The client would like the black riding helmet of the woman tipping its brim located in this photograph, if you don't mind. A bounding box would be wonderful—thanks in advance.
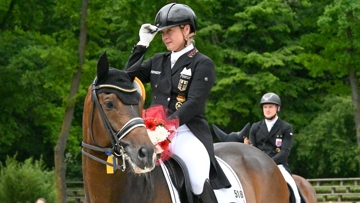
[155,3,197,32]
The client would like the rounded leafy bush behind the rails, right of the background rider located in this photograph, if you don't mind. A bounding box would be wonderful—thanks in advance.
[294,96,359,178]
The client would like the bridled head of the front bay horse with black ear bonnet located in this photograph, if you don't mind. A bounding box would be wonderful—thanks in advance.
[83,53,156,173]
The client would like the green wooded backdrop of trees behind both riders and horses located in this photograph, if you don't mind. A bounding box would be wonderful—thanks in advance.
[0,0,360,201]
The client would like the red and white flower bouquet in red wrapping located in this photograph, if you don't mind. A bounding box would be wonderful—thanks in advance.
[142,105,179,164]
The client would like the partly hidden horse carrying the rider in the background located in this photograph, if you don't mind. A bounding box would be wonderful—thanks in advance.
[213,123,318,203]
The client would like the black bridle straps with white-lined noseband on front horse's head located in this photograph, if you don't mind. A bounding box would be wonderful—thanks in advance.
[81,78,145,171]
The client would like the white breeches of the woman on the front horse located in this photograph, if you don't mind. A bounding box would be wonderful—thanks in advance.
[171,124,210,195]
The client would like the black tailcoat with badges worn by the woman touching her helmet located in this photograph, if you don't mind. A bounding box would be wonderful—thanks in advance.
[125,45,231,189]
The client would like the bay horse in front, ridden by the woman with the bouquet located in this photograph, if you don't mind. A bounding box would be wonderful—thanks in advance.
[82,53,289,203]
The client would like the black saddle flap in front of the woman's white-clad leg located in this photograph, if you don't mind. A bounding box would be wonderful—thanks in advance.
[164,154,194,203]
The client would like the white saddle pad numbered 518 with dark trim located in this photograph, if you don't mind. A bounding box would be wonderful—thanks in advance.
[160,157,246,203]
